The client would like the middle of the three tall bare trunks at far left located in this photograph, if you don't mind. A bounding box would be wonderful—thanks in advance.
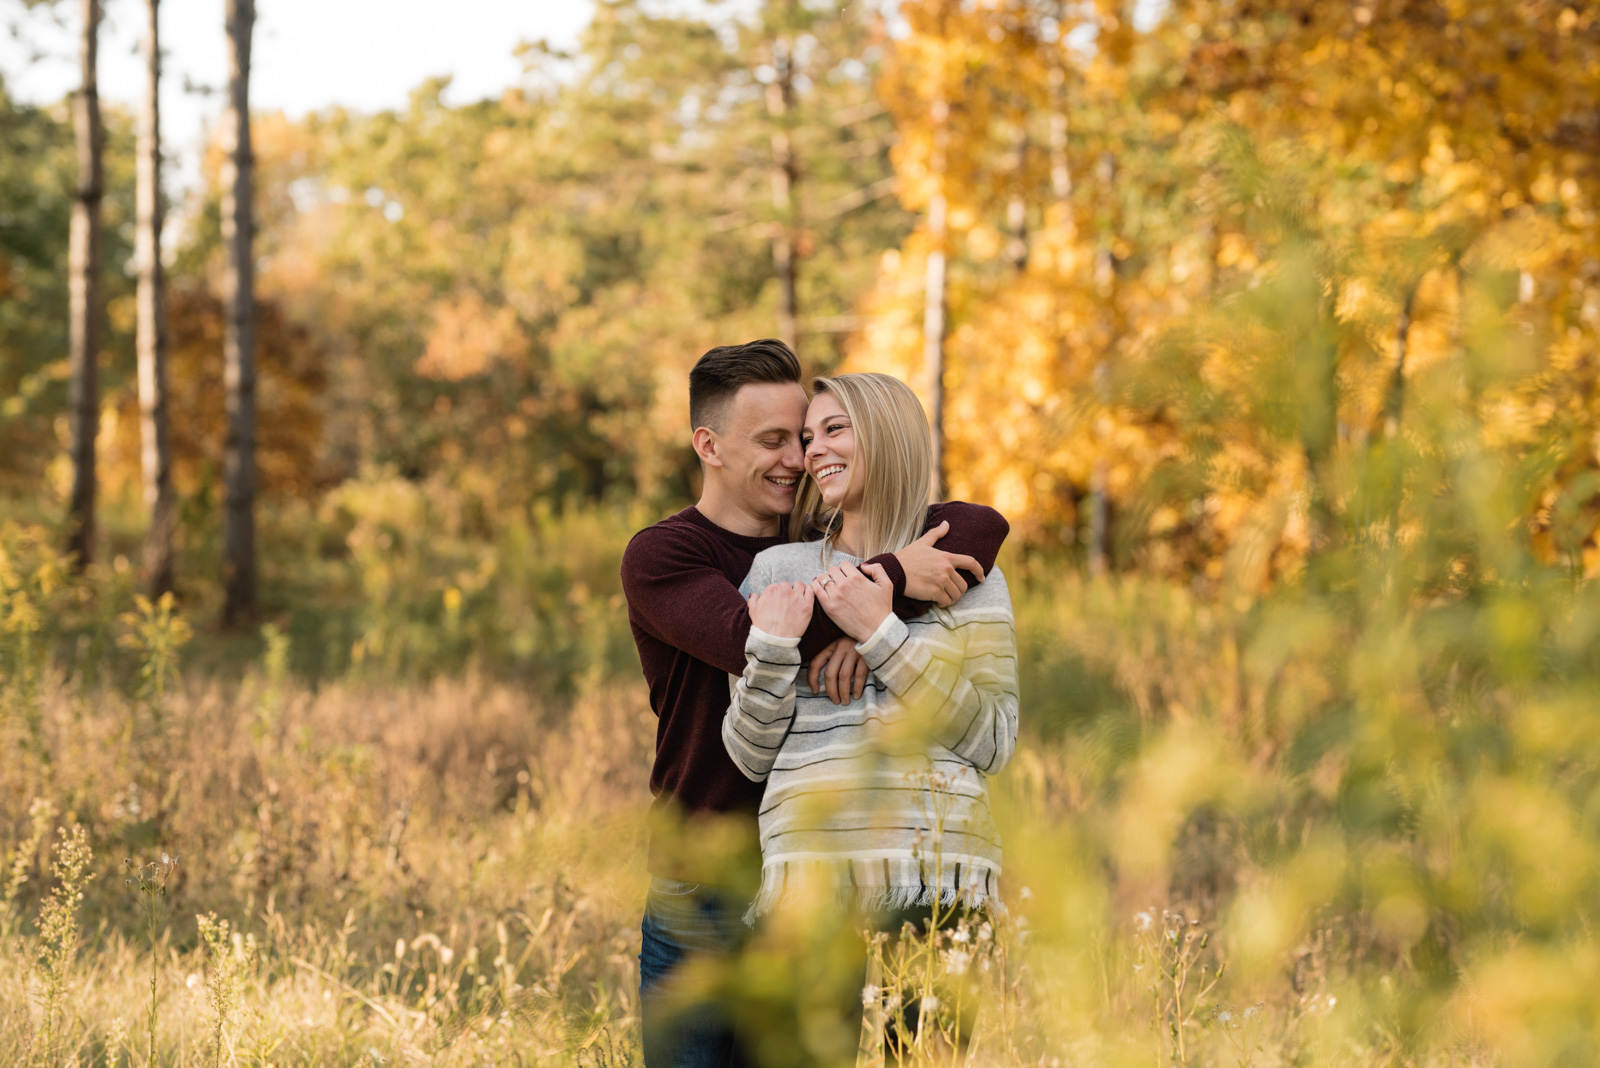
[134,0,178,596]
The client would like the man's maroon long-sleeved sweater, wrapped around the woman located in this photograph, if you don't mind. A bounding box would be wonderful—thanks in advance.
[622,502,1011,881]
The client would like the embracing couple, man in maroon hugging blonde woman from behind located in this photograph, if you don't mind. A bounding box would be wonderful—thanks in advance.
[622,339,1018,1068]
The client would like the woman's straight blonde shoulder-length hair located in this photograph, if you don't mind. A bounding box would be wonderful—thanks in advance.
[789,374,934,561]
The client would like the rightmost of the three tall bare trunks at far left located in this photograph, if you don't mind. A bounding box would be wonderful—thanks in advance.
[222,0,258,627]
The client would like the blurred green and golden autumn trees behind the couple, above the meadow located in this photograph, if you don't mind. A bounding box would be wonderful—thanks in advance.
[0,0,1600,629]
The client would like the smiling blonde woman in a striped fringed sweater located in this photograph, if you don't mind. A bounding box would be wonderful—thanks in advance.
[723,374,1018,919]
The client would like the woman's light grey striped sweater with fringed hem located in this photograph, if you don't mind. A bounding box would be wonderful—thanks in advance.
[722,542,1018,919]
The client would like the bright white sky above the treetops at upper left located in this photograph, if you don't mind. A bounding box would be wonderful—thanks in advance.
[0,0,594,185]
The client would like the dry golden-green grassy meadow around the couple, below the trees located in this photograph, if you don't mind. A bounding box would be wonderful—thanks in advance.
[0,463,1600,1068]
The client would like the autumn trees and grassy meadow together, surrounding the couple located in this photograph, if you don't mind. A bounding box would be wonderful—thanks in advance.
[0,0,1600,1065]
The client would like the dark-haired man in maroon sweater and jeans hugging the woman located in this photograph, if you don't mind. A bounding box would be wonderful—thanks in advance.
[622,339,1010,1068]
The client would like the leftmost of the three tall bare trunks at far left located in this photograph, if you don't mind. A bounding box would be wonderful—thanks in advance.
[67,0,106,568]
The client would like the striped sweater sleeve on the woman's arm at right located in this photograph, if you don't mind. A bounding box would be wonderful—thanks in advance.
[856,572,1018,775]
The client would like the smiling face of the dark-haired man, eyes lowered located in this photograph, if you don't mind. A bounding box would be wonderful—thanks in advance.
[707,382,806,520]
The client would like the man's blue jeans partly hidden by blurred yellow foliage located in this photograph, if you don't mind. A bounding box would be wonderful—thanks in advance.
[638,876,750,1068]
